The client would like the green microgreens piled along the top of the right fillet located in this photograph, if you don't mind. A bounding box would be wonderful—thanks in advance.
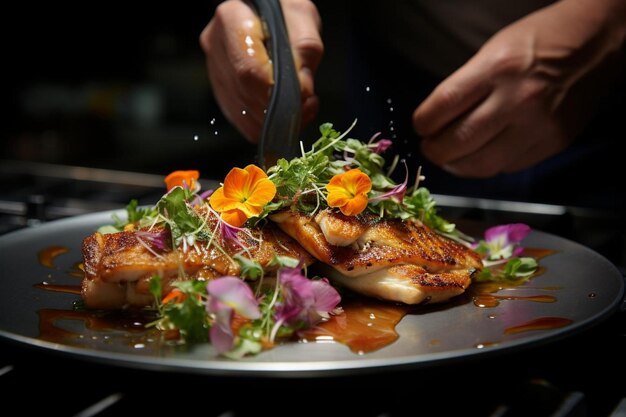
[252,121,472,242]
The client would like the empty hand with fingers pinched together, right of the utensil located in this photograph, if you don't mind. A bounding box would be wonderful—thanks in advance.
[413,0,626,177]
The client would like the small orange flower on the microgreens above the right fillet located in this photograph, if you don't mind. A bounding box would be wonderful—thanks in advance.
[326,168,372,216]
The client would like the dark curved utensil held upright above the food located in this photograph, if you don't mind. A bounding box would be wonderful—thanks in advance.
[252,0,302,169]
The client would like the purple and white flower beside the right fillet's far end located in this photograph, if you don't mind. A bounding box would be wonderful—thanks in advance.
[474,223,530,261]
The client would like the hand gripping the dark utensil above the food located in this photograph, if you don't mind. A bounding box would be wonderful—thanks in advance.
[200,0,324,142]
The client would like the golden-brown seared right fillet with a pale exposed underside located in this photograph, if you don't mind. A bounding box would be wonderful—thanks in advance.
[271,209,482,304]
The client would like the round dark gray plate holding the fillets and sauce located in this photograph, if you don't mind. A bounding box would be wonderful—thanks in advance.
[0,212,624,377]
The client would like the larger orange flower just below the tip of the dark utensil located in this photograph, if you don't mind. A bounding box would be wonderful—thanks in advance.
[209,165,276,227]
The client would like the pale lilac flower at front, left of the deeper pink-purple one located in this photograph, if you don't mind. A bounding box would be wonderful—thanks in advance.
[206,276,261,353]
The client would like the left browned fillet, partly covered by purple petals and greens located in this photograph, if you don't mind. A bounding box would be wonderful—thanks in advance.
[82,210,314,309]
